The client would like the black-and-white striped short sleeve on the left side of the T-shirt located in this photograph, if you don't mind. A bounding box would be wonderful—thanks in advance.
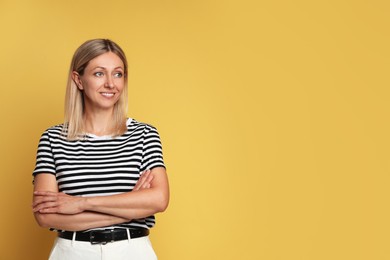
[33,131,56,176]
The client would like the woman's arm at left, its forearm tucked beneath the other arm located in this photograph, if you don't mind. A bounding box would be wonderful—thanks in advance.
[33,173,129,231]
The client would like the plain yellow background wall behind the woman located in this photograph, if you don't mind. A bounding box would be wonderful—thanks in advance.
[0,0,390,260]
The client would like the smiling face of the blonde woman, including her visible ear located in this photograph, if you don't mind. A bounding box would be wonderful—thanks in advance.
[72,52,125,112]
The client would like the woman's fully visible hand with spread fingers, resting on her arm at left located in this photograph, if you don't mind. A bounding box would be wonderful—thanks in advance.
[32,191,85,214]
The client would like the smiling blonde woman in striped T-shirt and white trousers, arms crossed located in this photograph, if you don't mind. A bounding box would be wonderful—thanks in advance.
[33,39,169,260]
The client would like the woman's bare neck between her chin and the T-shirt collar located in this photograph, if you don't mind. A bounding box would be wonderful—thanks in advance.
[84,108,115,136]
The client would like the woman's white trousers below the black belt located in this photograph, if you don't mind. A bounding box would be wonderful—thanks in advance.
[49,236,157,260]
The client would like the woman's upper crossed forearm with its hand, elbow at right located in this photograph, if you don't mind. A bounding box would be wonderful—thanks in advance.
[34,167,169,219]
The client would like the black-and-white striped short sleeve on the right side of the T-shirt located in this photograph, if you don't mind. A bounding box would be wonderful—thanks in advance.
[141,125,165,171]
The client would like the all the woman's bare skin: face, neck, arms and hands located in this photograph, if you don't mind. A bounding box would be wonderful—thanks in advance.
[32,52,169,231]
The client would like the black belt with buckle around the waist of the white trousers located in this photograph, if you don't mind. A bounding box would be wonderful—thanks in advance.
[58,228,149,244]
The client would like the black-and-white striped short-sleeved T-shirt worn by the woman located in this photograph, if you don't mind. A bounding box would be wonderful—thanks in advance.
[33,118,165,228]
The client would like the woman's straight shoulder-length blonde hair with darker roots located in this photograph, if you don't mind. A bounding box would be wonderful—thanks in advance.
[63,39,128,140]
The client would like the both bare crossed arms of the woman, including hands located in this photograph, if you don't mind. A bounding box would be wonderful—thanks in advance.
[33,167,169,230]
